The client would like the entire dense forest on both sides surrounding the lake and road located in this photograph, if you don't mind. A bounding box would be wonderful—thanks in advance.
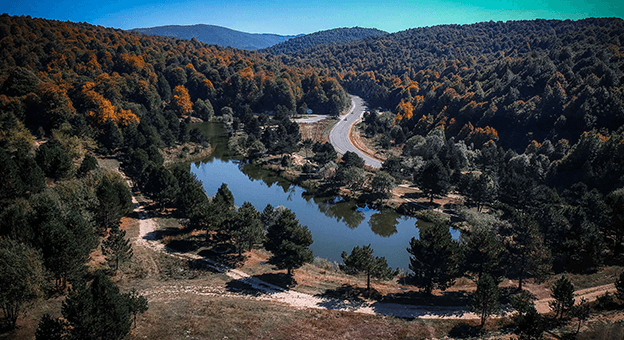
[0,14,624,337]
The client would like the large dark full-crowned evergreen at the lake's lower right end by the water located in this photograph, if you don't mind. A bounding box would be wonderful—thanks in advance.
[407,223,460,294]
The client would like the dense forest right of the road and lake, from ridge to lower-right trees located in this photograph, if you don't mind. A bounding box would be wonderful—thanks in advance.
[262,18,624,277]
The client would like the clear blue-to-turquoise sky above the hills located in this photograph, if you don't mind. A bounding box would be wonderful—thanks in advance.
[0,0,624,35]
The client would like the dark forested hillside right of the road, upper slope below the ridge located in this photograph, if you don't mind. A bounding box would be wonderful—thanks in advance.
[282,18,624,151]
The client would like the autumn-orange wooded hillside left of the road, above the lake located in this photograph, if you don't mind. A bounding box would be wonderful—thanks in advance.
[0,14,349,163]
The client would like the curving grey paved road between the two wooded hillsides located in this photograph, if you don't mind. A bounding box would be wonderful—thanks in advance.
[329,96,381,169]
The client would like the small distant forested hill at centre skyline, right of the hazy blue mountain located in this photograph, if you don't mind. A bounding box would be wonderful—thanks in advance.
[261,27,388,54]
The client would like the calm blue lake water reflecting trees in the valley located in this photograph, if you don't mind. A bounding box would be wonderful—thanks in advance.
[191,123,459,270]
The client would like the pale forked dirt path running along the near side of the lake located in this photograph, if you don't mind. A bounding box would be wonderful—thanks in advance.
[132,190,615,320]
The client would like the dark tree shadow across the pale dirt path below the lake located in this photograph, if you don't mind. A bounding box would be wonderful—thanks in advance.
[226,273,297,296]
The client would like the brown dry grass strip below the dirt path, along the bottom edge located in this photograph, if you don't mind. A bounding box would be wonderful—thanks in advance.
[130,293,466,339]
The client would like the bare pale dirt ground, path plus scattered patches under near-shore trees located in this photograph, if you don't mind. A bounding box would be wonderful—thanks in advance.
[128,191,615,320]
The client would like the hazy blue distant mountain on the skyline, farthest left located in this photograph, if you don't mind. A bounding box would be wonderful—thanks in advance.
[132,25,296,50]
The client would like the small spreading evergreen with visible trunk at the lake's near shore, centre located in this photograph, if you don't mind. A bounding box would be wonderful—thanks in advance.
[340,244,398,294]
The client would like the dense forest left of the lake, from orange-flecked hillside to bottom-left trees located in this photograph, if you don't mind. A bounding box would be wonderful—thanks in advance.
[0,14,349,338]
